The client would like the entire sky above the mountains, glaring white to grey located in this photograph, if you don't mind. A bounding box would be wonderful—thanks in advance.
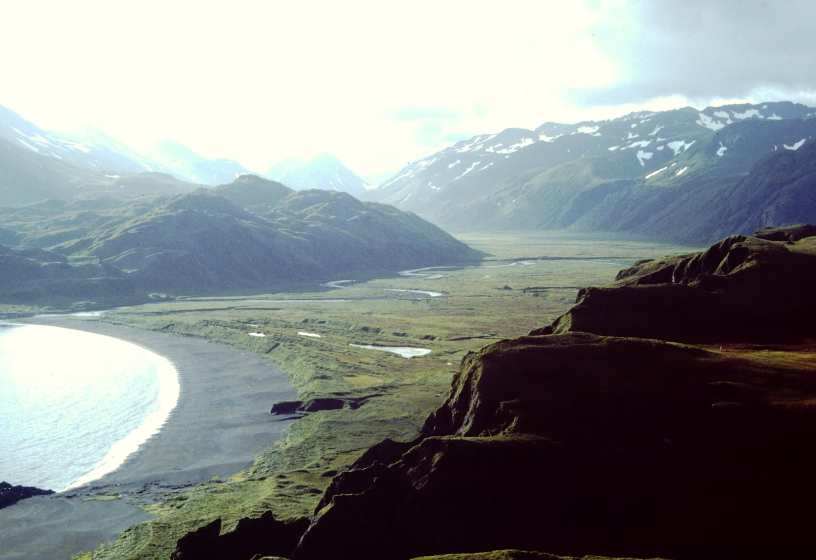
[0,0,816,183]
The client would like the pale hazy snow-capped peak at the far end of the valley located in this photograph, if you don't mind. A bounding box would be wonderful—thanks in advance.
[264,154,366,196]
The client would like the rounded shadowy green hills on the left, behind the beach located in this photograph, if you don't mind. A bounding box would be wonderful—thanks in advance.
[0,176,480,306]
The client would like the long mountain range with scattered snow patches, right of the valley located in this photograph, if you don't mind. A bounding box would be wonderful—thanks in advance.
[368,102,816,244]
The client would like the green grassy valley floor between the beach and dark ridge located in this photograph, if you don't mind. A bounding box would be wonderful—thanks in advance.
[55,234,696,559]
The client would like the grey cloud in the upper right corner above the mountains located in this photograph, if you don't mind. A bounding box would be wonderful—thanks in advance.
[570,0,816,106]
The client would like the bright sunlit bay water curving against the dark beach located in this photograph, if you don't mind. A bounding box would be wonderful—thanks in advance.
[0,325,179,491]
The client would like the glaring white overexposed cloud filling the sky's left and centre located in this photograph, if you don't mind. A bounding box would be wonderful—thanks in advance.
[0,0,616,177]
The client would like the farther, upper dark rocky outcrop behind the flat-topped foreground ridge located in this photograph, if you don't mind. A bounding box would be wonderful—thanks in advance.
[533,230,816,343]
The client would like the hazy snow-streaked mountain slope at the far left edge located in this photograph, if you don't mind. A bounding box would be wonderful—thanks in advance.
[0,106,155,173]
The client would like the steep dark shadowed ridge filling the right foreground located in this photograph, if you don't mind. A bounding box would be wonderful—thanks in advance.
[284,228,816,560]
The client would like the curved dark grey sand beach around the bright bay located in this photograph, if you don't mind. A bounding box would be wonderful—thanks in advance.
[0,316,296,560]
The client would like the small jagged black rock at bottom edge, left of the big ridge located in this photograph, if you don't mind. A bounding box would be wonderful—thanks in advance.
[172,511,309,560]
